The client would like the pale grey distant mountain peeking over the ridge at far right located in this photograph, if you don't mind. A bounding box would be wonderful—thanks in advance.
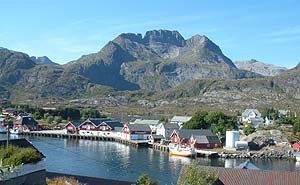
[234,59,288,76]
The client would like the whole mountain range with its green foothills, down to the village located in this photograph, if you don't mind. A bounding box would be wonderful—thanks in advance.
[0,30,300,114]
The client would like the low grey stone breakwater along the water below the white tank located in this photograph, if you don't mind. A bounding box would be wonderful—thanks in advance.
[218,150,295,159]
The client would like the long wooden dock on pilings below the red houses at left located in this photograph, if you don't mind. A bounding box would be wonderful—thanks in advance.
[23,131,149,147]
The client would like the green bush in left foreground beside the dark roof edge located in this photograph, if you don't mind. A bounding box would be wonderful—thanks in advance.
[0,145,42,166]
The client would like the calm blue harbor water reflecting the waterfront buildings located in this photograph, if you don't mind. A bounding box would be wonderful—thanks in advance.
[0,134,300,185]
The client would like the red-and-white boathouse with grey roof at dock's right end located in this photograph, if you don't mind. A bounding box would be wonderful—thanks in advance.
[122,124,151,140]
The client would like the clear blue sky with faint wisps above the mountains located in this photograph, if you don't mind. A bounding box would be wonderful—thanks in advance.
[0,0,300,68]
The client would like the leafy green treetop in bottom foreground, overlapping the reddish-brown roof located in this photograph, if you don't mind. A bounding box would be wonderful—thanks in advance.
[177,160,218,185]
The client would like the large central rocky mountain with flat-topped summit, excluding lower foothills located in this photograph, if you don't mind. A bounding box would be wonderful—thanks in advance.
[66,30,260,91]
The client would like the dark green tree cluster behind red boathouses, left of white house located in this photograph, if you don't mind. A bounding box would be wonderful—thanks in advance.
[183,111,237,138]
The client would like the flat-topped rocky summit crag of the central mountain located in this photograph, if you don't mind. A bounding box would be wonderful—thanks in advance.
[143,30,185,47]
